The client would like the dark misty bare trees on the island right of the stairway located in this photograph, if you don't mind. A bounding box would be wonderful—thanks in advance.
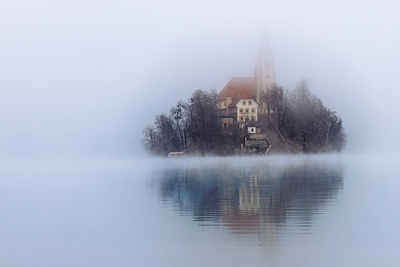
[263,81,346,153]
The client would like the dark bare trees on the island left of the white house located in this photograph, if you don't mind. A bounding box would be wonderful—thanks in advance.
[142,90,243,155]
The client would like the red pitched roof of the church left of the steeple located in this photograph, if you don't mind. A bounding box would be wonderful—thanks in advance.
[218,77,257,100]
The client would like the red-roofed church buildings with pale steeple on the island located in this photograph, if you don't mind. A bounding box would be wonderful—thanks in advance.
[218,51,275,128]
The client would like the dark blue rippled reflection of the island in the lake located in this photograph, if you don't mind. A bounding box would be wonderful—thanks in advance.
[157,159,343,245]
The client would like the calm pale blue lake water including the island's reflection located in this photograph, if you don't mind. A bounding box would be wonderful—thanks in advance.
[0,155,400,267]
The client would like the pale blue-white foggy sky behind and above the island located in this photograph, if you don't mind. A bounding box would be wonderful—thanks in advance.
[0,0,400,157]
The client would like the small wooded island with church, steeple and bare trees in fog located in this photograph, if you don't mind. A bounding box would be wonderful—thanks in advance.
[142,50,346,156]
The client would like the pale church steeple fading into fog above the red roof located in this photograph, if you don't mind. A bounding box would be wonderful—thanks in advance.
[255,49,275,112]
